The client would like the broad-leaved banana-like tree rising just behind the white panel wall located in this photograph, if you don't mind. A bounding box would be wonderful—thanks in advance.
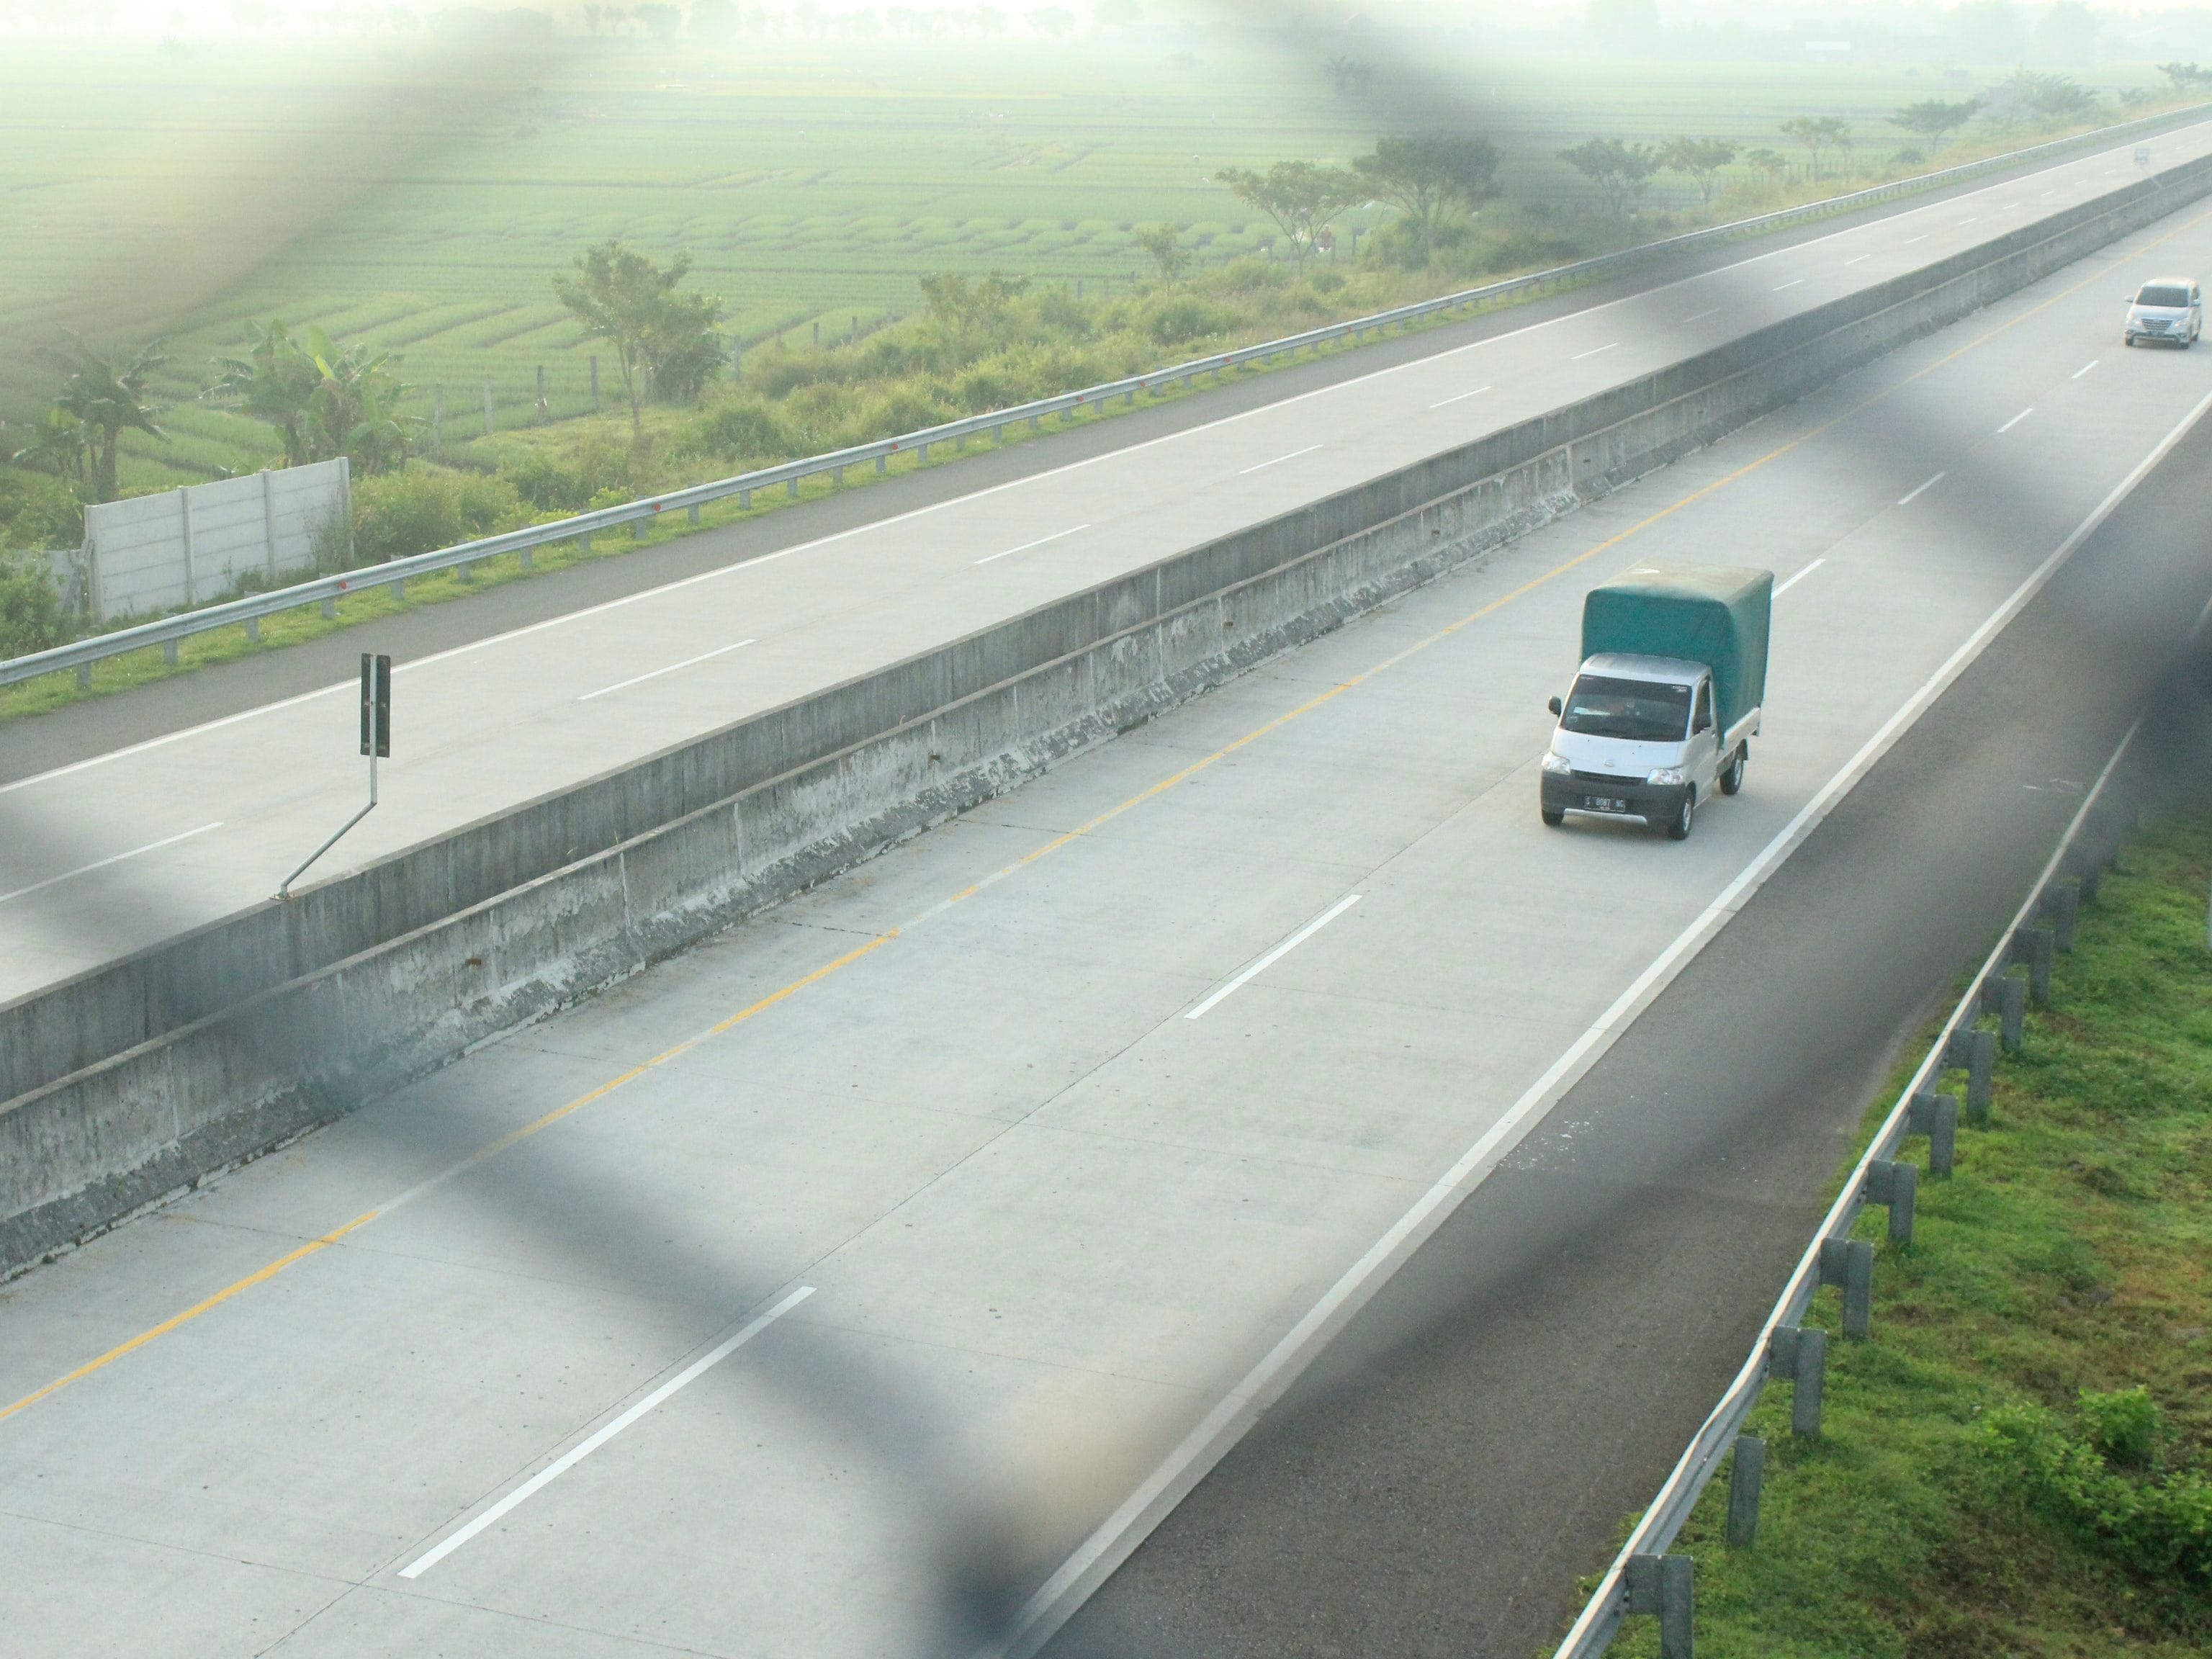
[204,320,423,473]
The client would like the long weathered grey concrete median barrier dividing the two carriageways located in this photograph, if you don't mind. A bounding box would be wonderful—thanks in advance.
[0,149,2212,1269]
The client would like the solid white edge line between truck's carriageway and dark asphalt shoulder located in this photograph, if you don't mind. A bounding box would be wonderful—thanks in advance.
[980,376,2212,1659]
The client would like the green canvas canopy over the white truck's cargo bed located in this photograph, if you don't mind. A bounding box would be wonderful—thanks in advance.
[1581,564,1774,732]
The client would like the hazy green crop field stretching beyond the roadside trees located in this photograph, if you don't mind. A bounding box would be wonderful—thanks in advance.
[0,35,2154,491]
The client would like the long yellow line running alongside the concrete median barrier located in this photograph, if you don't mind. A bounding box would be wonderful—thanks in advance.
[13,210,2212,1420]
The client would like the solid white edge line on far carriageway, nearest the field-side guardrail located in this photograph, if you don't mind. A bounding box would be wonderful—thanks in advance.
[13,122,2212,794]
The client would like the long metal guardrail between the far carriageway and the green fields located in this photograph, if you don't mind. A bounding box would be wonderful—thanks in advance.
[0,104,2212,685]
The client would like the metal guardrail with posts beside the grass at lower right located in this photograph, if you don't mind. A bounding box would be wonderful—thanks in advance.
[1553,721,2141,1659]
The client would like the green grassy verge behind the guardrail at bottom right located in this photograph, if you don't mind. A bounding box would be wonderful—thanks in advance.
[1612,796,2212,1659]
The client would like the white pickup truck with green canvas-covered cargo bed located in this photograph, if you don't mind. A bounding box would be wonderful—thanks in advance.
[1539,564,1774,840]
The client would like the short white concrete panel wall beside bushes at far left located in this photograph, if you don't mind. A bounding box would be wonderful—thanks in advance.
[75,456,351,621]
